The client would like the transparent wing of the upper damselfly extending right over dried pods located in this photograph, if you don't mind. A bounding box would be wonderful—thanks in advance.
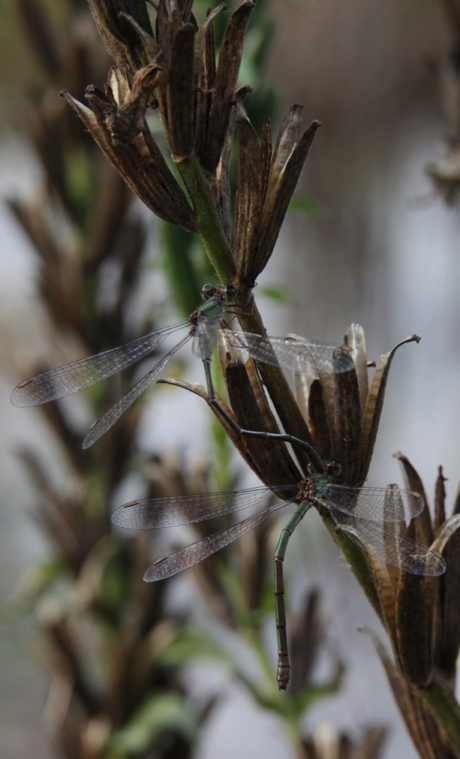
[222,330,354,374]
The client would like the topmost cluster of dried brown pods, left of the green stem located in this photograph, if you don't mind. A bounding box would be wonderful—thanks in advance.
[64,0,253,236]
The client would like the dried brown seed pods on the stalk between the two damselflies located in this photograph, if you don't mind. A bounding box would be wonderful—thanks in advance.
[210,324,419,486]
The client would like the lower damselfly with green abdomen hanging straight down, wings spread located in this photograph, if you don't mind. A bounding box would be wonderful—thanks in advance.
[112,464,446,690]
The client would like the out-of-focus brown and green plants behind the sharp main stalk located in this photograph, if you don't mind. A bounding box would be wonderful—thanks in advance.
[4,0,383,759]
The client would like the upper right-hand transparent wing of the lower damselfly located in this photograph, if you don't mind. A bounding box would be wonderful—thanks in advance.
[318,485,425,522]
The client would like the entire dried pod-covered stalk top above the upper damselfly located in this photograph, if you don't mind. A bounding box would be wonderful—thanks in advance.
[63,0,319,290]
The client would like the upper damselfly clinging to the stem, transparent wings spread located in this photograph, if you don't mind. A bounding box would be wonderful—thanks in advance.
[11,285,351,448]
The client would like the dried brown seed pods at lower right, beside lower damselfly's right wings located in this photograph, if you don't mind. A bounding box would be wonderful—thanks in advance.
[358,453,460,757]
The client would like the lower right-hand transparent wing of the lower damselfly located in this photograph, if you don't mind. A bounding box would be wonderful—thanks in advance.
[334,513,446,577]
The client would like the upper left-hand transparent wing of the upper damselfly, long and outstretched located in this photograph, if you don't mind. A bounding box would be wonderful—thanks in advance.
[11,321,190,406]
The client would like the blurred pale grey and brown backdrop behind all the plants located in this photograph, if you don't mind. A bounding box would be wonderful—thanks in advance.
[0,0,460,759]
